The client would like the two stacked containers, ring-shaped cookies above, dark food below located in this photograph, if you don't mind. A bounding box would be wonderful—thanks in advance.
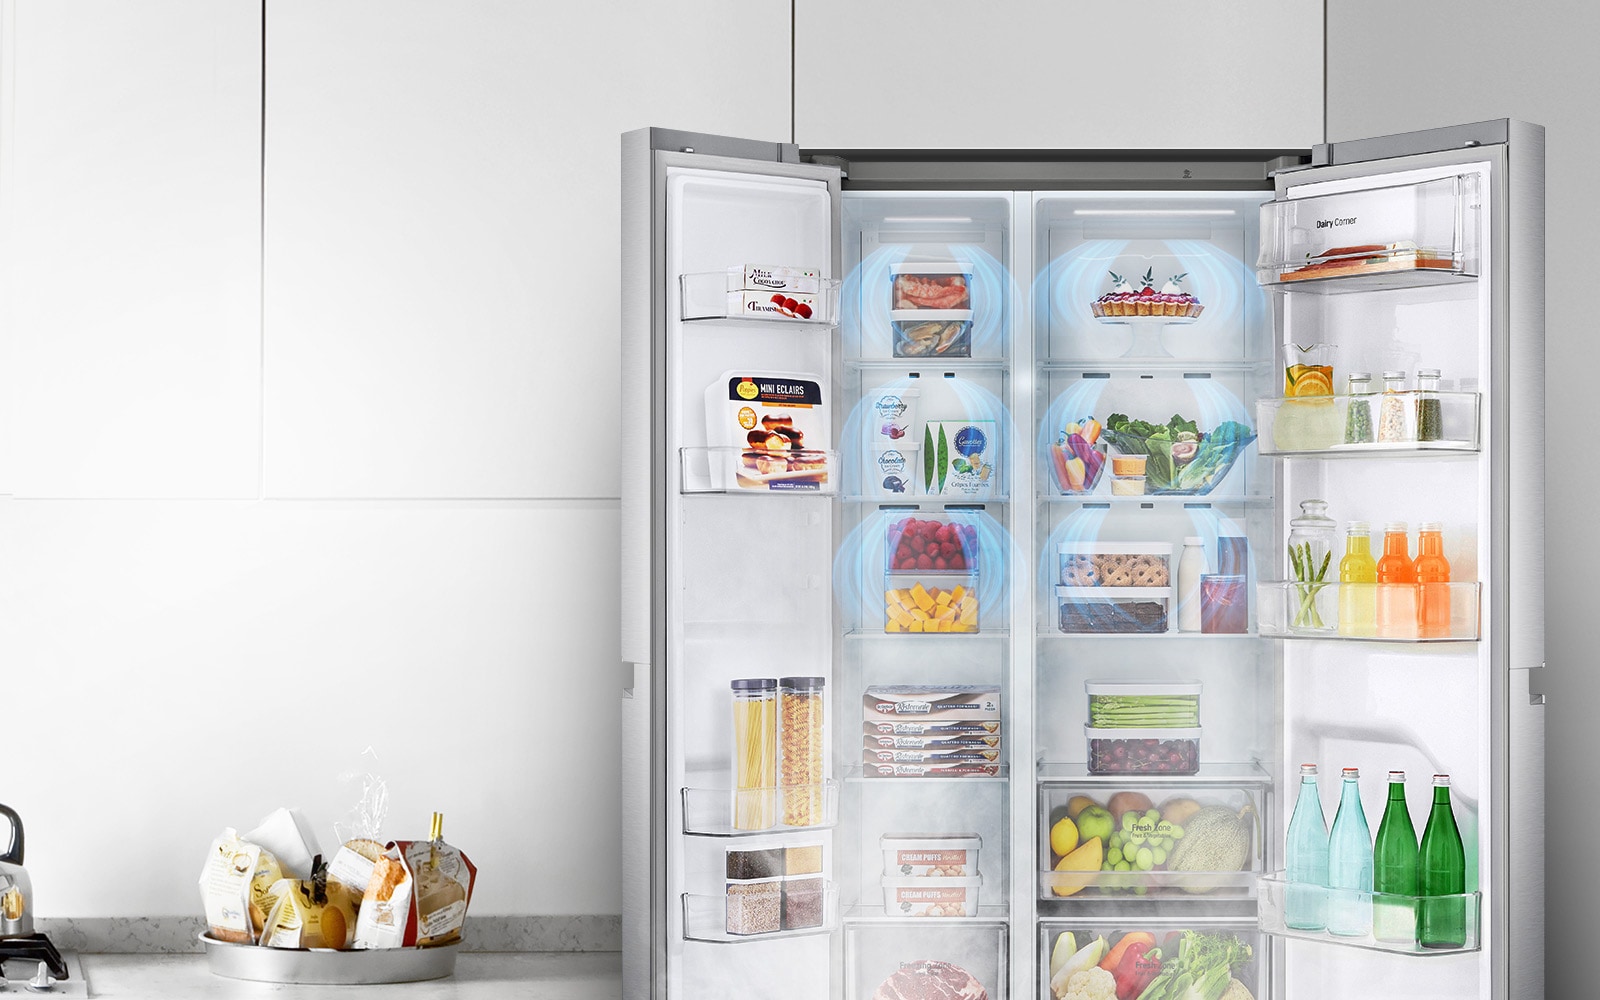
[1056,541,1173,632]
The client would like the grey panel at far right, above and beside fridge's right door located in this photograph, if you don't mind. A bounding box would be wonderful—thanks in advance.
[1328,0,1600,997]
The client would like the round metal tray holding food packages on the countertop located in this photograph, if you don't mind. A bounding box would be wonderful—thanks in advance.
[200,933,461,986]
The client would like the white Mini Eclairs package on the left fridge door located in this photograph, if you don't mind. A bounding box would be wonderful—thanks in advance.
[706,370,832,491]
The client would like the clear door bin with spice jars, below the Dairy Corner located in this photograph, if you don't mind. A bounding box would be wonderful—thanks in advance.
[1256,389,1480,458]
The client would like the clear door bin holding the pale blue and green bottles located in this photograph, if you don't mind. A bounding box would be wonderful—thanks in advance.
[1256,872,1483,955]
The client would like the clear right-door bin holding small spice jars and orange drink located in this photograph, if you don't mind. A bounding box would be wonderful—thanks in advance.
[1256,389,1480,458]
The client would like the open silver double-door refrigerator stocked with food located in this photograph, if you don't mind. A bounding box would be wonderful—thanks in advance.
[619,120,1544,1000]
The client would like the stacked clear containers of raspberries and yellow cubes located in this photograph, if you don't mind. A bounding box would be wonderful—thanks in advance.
[883,510,978,632]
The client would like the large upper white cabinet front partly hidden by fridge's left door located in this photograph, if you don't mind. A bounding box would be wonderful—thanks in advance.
[264,0,789,498]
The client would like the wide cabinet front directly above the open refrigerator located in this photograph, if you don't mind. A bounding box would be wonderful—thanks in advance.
[795,0,1323,149]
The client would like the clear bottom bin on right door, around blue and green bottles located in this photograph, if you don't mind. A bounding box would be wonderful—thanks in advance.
[1256,872,1483,957]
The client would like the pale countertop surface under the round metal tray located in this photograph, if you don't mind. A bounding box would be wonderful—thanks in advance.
[78,952,622,1000]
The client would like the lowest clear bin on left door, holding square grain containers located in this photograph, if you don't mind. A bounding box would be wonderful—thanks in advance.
[682,878,838,944]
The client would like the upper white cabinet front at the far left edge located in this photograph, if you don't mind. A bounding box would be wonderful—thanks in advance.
[0,0,261,498]
